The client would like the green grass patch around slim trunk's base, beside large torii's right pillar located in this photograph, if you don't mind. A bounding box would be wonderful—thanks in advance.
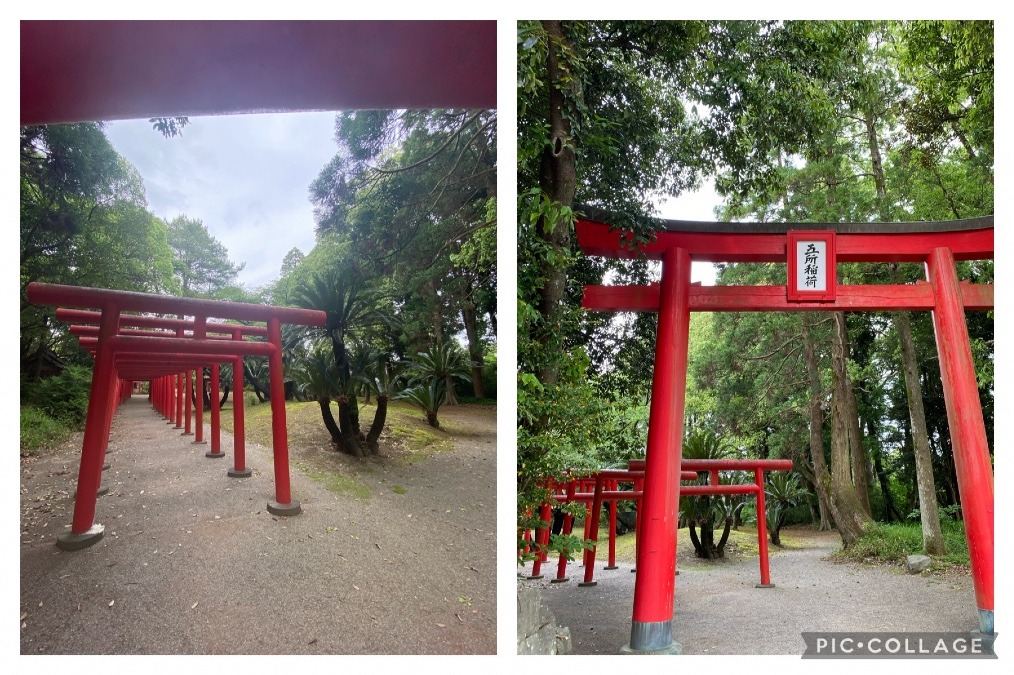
[835,521,969,568]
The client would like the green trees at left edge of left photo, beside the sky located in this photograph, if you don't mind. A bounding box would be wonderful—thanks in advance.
[20,123,177,374]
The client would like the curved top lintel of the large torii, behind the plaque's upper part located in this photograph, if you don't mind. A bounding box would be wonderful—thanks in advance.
[575,219,993,263]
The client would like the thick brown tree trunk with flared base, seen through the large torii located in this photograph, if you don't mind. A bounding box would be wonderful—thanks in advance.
[830,312,872,548]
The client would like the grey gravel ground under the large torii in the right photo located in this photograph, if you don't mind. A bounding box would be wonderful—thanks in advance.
[521,530,977,655]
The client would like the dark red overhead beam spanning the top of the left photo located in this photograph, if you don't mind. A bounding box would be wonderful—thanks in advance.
[21,20,497,125]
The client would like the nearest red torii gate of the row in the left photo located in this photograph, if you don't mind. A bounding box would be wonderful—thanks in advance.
[27,283,327,550]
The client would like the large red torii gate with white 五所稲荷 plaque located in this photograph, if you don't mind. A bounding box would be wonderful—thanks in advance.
[576,207,994,653]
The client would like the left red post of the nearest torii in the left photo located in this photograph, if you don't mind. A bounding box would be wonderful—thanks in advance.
[57,304,120,550]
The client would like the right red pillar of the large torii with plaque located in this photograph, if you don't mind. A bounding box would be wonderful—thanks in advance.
[926,248,994,634]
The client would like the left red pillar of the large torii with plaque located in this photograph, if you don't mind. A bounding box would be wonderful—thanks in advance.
[624,247,691,653]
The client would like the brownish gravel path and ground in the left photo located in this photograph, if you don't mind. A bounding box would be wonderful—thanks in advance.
[20,396,496,654]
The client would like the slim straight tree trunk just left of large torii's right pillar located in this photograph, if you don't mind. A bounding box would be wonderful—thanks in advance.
[894,273,944,555]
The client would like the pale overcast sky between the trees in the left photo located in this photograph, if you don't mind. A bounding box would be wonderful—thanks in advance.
[105,113,337,290]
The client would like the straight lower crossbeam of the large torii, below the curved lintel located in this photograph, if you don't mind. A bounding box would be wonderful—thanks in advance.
[581,282,993,312]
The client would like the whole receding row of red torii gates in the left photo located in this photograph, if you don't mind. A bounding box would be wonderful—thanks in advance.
[27,283,327,550]
